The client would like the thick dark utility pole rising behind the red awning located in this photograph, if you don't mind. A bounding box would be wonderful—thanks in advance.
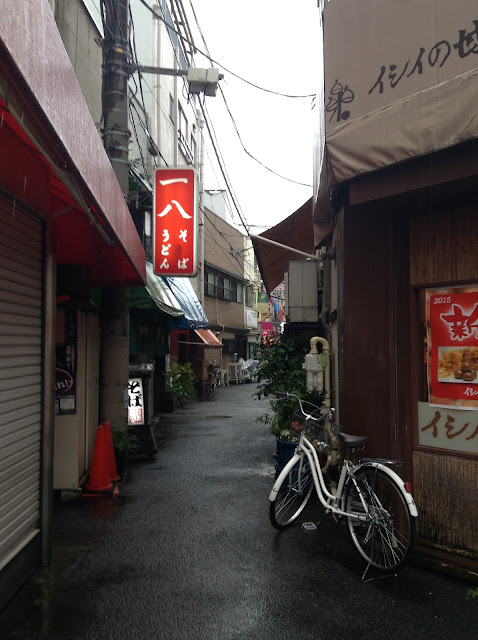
[99,0,129,426]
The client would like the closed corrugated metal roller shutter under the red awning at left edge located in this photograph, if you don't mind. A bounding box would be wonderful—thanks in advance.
[0,196,43,569]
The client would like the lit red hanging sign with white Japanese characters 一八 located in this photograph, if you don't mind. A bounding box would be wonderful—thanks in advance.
[153,167,197,278]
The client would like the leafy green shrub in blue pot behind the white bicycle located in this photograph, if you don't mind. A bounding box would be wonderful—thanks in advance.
[254,334,323,472]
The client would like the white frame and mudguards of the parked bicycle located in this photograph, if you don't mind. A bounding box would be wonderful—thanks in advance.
[269,434,418,521]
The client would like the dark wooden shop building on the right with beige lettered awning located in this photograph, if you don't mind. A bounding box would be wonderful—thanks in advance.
[314,0,478,575]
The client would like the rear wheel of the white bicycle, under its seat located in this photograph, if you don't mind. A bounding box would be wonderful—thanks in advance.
[344,467,416,572]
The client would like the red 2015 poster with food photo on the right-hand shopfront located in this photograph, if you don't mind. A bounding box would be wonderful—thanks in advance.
[426,287,478,409]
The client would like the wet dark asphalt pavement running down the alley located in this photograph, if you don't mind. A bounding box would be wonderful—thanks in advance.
[0,383,478,640]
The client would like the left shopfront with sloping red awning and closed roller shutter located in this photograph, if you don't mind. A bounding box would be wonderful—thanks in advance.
[0,0,146,603]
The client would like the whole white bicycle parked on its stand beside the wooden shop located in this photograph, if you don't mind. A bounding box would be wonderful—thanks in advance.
[269,393,418,579]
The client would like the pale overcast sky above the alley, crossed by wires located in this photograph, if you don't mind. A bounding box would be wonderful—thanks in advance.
[184,0,322,233]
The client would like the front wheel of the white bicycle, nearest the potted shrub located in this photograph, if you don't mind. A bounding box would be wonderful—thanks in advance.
[270,455,314,529]
